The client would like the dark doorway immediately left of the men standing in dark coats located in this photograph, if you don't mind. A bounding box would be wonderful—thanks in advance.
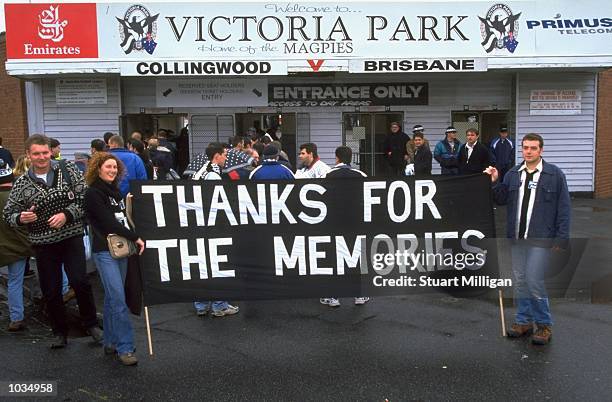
[342,112,404,176]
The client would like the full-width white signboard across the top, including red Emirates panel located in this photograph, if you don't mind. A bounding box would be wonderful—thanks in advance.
[5,0,612,76]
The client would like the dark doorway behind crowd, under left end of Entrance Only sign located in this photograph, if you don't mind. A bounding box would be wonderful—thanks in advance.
[235,113,297,167]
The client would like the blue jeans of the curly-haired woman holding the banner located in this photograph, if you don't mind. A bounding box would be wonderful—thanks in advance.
[93,251,134,354]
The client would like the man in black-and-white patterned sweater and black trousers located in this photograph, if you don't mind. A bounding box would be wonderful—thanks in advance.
[4,134,102,349]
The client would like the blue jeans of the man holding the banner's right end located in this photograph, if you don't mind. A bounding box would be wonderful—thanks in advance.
[512,244,553,325]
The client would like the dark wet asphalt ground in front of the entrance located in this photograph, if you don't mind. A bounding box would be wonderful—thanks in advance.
[0,200,612,401]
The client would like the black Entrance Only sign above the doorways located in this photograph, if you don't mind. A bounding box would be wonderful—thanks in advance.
[268,82,429,107]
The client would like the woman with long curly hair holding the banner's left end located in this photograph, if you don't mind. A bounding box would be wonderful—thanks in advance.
[85,152,145,366]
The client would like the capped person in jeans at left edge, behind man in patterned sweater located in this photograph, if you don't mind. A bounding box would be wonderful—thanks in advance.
[0,159,34,332]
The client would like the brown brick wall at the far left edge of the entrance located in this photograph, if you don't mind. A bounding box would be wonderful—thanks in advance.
[0,33,28,159]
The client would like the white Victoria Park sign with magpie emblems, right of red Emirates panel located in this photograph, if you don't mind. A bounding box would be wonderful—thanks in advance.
[97,1,532,61]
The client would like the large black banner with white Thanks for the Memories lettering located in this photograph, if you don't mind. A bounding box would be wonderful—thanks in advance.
[132,175,498,305]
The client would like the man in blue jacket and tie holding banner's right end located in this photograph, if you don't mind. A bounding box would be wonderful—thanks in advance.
[485,134,571,345]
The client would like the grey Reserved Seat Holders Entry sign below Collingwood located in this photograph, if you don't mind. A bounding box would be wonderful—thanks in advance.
[155,78,268,107]
